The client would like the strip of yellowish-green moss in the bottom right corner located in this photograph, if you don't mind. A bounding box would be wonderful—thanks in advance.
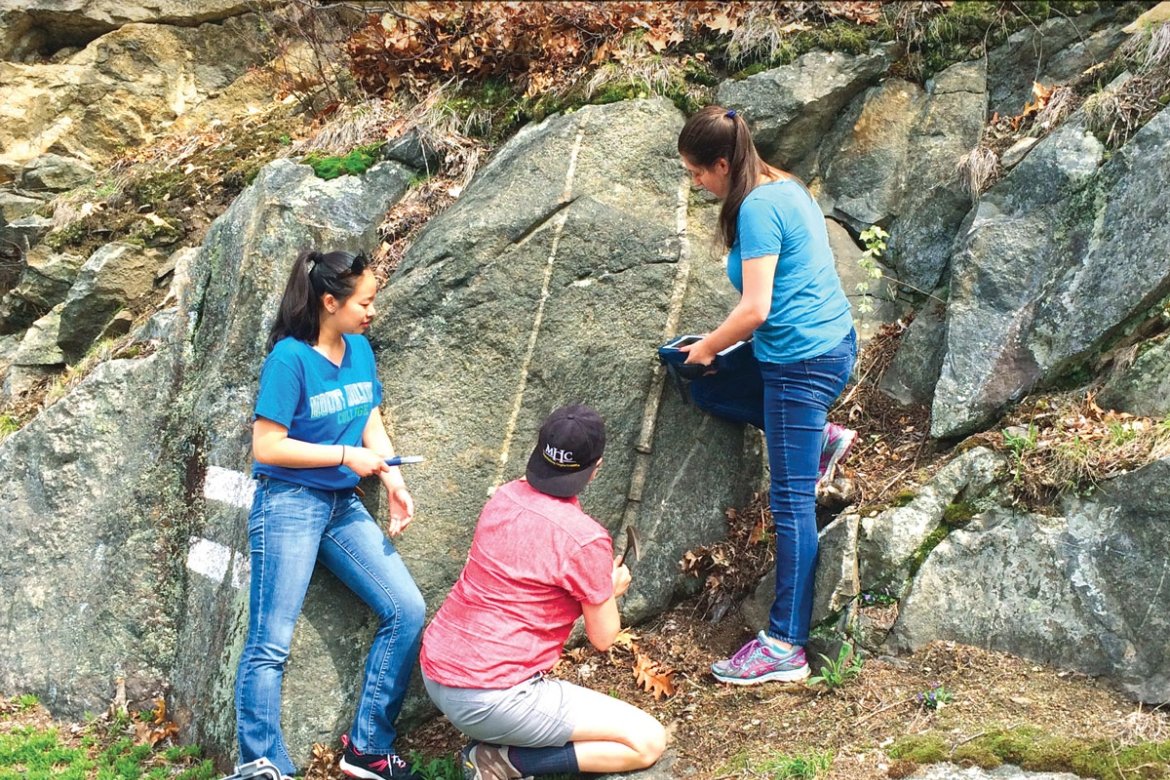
[887,726,1170,780]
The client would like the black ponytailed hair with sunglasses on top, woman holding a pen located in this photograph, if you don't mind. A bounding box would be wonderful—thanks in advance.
[268,250,369,352]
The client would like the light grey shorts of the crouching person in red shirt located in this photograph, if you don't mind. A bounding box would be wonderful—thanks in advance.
[422,675,608,747]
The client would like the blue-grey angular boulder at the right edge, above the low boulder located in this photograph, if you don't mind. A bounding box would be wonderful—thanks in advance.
[930,110,1170,437]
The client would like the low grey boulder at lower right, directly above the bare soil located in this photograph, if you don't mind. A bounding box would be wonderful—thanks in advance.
[888,460,1170,703]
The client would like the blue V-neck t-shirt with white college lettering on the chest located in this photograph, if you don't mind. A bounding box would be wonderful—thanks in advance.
[252,334,381,490]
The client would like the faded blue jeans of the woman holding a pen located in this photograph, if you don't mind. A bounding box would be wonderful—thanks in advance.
[235,477,426,774]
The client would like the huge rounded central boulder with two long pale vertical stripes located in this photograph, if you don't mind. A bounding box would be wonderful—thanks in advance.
[371,101,761,620]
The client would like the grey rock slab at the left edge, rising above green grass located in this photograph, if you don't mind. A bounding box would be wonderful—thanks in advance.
[0,353,183,716]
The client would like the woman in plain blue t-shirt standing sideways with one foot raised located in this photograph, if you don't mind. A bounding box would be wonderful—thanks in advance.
[679,105,856,685]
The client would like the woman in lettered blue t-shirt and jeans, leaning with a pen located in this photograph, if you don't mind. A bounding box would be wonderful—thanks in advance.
[236,251,425,780]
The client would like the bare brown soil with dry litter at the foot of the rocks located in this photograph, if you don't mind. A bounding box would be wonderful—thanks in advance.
[388,601,1170,780]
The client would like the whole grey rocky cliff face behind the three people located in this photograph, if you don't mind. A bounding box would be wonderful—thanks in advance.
[0,2,1170,755]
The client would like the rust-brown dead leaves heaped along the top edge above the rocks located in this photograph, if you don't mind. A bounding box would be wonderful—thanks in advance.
[346,0,882,97]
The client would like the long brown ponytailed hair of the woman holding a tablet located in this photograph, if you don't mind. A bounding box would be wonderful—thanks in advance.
[679,105,769,249]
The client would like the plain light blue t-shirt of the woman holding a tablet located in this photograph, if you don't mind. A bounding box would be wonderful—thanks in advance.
[728,179,853,363]
